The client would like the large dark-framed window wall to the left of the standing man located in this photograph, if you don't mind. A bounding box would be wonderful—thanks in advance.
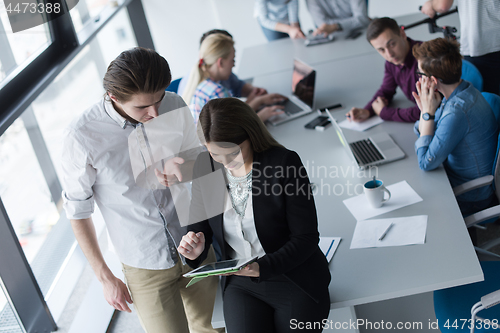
[0,0,152,333]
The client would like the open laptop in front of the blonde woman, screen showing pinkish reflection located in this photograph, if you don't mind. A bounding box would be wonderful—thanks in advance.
[268,59,316,125]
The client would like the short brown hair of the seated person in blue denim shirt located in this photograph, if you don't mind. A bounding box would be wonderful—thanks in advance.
[413,38,462,84]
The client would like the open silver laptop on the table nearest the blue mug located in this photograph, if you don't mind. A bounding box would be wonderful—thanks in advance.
[326,110,405,169]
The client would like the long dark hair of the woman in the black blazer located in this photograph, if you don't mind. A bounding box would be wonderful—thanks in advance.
[198,98,282,153]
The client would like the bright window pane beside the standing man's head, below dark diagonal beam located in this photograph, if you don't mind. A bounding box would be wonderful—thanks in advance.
[32,6,137,179]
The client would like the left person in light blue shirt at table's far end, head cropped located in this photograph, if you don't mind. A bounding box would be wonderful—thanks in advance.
[254,0,305,41]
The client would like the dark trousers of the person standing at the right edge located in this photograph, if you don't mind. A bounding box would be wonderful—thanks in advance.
[464,51,500,95]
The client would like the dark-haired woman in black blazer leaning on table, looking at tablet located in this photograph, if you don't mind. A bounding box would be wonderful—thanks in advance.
[178,98,330,333]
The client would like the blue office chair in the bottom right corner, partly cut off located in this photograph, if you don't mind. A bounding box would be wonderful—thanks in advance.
[434,261,500,333]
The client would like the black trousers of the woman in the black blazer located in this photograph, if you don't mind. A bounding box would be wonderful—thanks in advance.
[224,275,330,333]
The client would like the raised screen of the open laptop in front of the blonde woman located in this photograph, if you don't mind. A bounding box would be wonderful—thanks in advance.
[292,59,316,109]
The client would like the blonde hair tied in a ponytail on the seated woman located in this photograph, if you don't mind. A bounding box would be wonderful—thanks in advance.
[182,34,234,105]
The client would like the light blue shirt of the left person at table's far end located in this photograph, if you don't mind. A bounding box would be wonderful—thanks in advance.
[254,0,299,30]
